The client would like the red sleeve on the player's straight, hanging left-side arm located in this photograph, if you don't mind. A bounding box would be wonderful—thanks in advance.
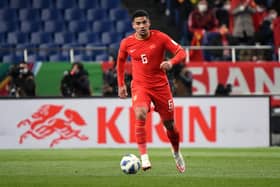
[117,39,127,87]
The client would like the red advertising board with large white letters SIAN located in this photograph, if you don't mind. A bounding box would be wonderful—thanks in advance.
[102,62,280,106]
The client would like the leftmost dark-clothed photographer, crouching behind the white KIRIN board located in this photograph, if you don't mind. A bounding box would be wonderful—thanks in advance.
[8,62,36,97]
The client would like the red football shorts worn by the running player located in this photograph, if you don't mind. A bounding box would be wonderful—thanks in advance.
[131,84,174,121]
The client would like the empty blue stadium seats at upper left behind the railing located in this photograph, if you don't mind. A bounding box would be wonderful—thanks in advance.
[0,0,131,62]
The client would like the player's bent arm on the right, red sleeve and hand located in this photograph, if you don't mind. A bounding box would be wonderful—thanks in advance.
[160,36,186,71]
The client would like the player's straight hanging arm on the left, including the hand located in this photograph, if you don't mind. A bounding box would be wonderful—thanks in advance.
[117,40,128,98]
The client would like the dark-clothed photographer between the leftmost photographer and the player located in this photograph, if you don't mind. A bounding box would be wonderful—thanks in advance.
[60,62,91,97]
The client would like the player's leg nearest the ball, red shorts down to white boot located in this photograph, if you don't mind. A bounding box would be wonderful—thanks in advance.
[132,85,151,171]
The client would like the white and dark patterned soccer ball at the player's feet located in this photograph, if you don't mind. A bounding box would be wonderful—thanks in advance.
[120,154,141,174]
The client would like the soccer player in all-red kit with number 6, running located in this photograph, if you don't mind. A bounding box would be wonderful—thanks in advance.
[117,10,186,173]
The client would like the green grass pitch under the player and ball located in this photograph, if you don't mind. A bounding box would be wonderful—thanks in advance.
[0,147,280,187]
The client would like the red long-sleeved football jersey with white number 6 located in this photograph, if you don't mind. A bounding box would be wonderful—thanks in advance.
[117,30,186,88]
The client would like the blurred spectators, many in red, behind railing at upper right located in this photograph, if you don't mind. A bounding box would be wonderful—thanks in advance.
[161,0,280,61]
